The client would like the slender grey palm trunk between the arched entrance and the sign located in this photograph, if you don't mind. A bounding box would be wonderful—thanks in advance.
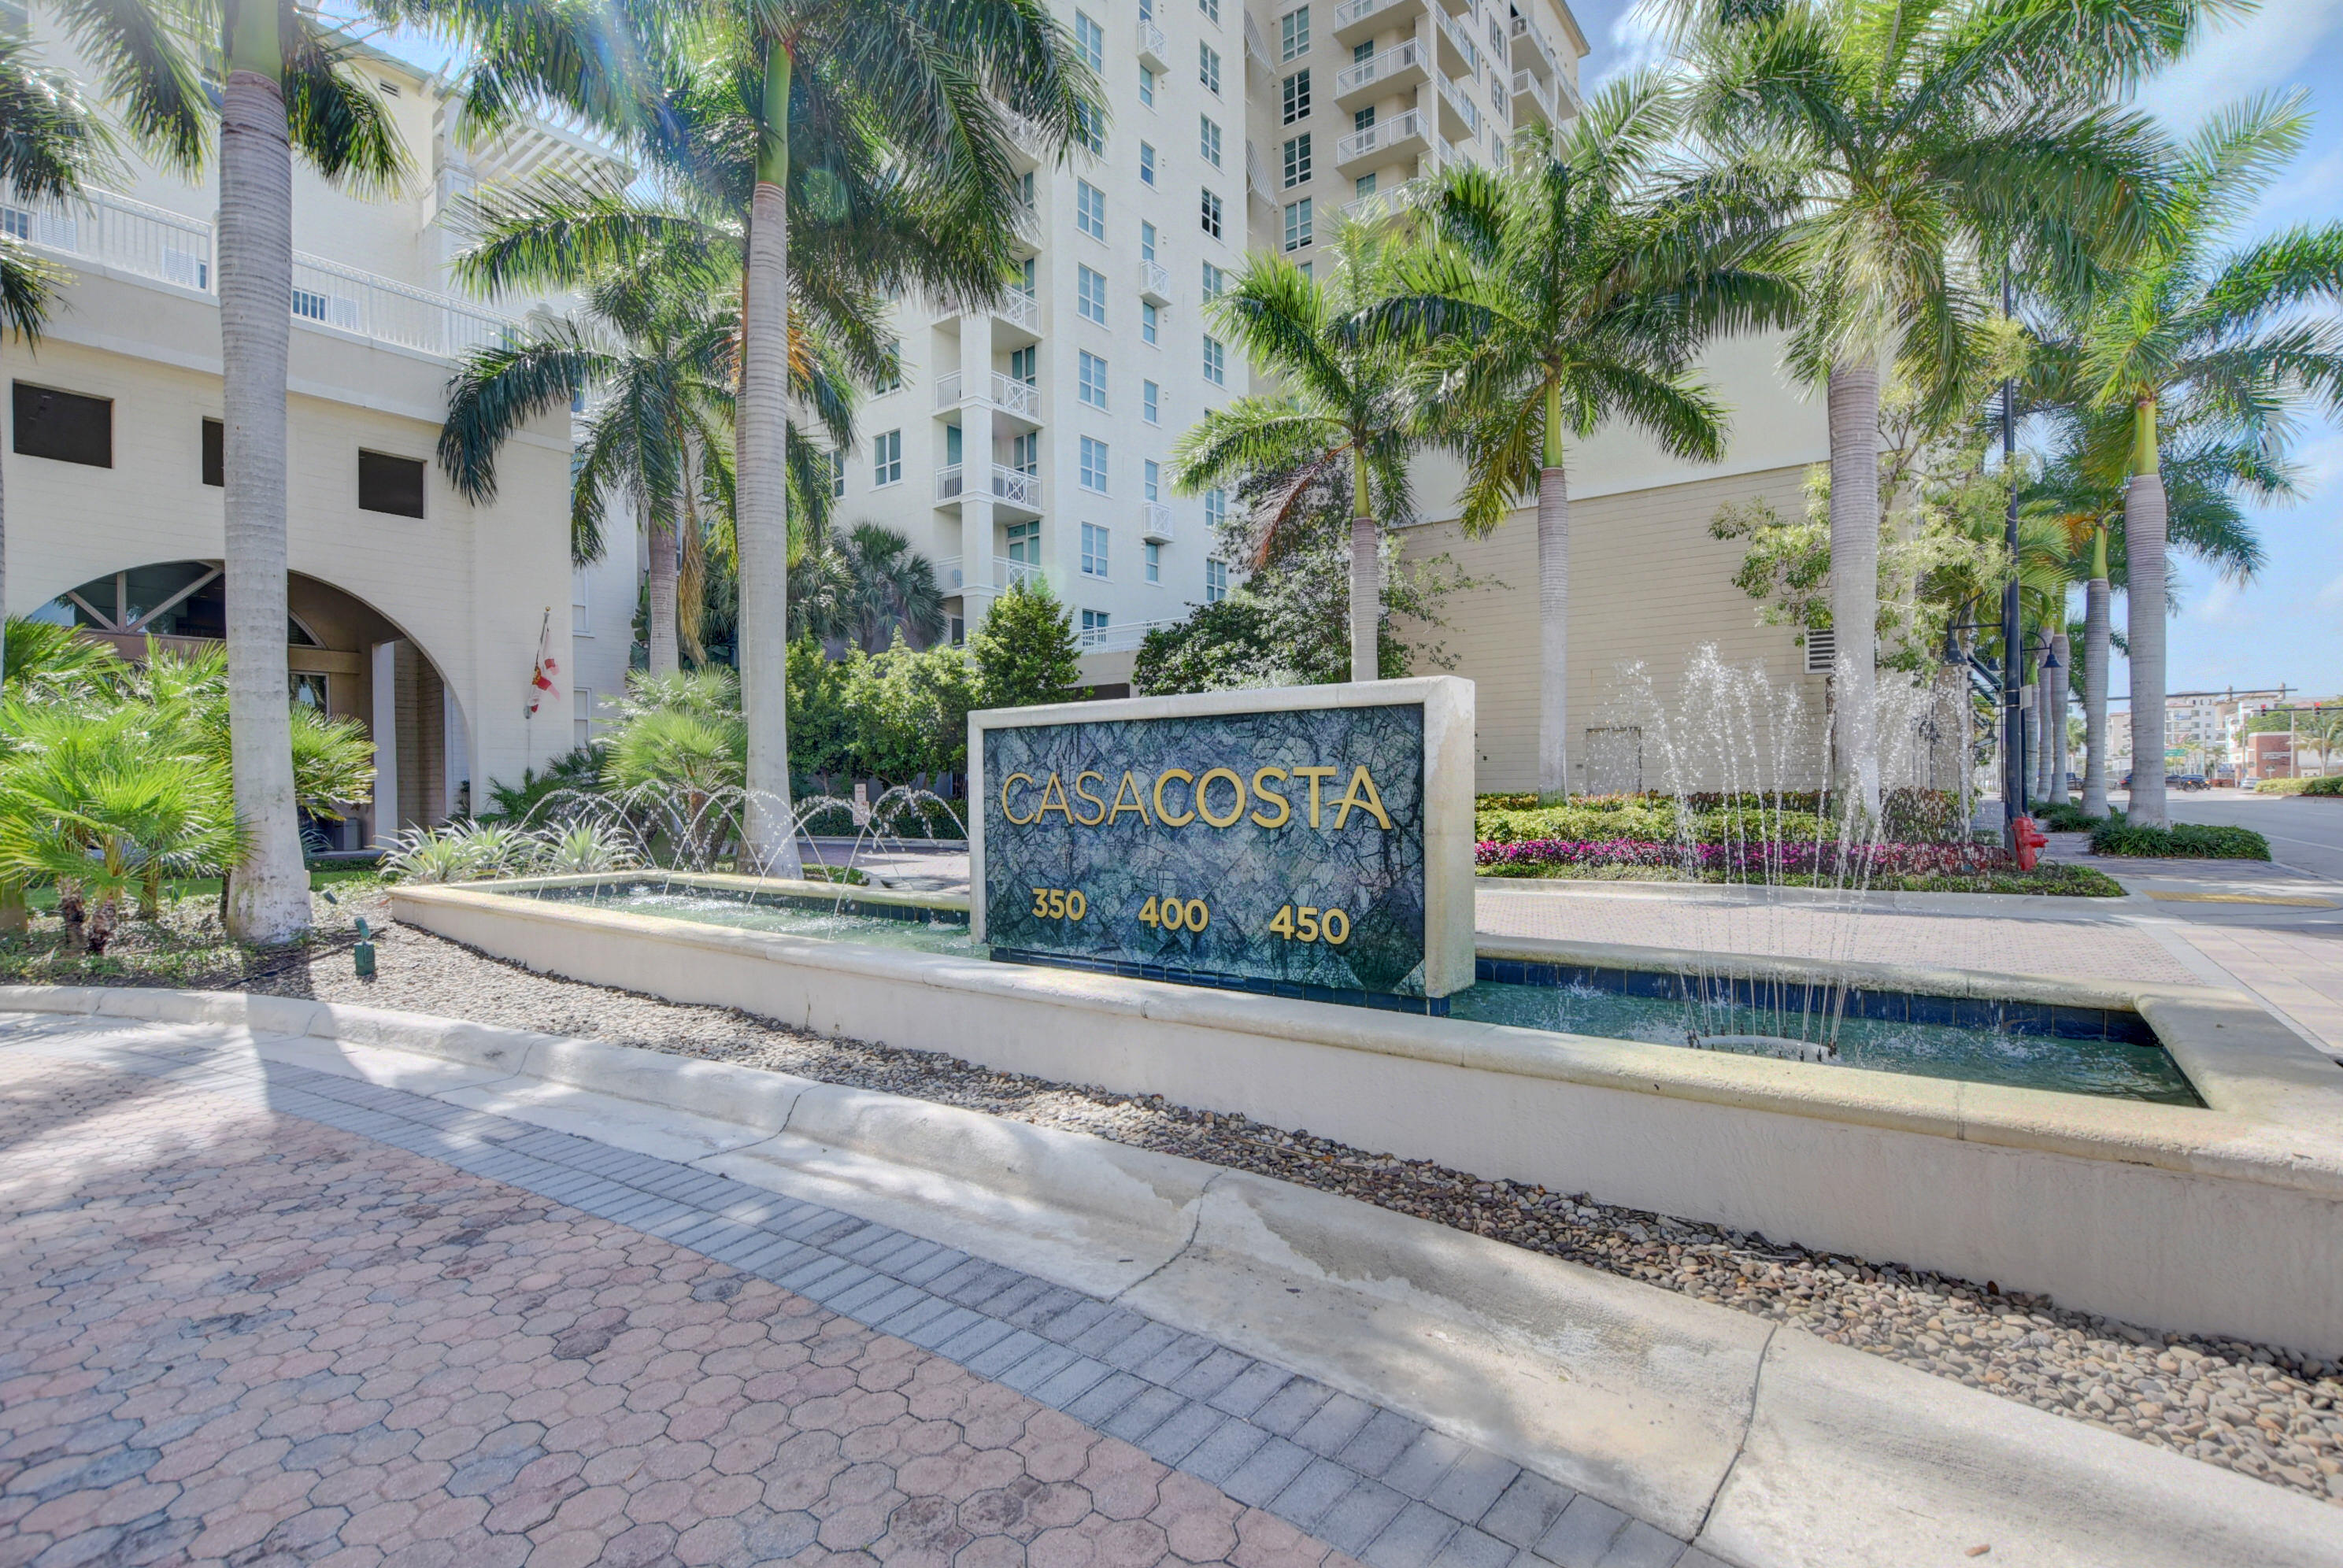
[733,40,804,877]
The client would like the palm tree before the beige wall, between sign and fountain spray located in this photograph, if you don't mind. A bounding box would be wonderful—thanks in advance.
[1366,75,1793,794]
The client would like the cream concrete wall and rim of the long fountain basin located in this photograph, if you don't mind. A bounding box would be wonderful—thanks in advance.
[391,889,2343,1355]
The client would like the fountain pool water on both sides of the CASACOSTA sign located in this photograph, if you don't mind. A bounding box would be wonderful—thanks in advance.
[508,882,2204,1106]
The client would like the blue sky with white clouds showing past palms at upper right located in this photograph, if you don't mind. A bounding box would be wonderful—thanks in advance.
[1565,0,2343,696]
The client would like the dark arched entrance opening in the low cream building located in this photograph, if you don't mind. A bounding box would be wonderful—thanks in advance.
[33,560,471,853]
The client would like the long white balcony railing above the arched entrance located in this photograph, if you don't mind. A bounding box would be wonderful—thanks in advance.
[18,190,518,359]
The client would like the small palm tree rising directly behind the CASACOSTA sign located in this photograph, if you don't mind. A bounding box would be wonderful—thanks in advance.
[1172,223,1424,679]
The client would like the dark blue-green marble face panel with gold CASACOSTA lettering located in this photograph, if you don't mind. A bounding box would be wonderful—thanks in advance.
[979,701,1427,996]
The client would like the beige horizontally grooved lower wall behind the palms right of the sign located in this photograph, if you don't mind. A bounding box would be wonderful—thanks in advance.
[1404,464,1825,790]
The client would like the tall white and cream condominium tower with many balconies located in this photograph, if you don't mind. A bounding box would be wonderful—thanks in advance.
[834,0,1586,679]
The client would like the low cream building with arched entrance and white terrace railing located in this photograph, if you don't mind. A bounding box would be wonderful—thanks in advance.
[0,14,637,830]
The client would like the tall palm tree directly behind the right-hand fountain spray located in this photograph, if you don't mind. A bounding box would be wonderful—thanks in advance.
[1675,0,2207,811]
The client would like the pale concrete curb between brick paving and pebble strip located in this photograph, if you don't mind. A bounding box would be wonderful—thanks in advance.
[0,987,2343,1568]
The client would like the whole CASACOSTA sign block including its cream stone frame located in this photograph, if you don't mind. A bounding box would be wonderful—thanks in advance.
[968,675,1474,1000]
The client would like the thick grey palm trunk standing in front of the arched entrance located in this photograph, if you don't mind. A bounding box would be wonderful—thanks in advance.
[218,57,309,942]
